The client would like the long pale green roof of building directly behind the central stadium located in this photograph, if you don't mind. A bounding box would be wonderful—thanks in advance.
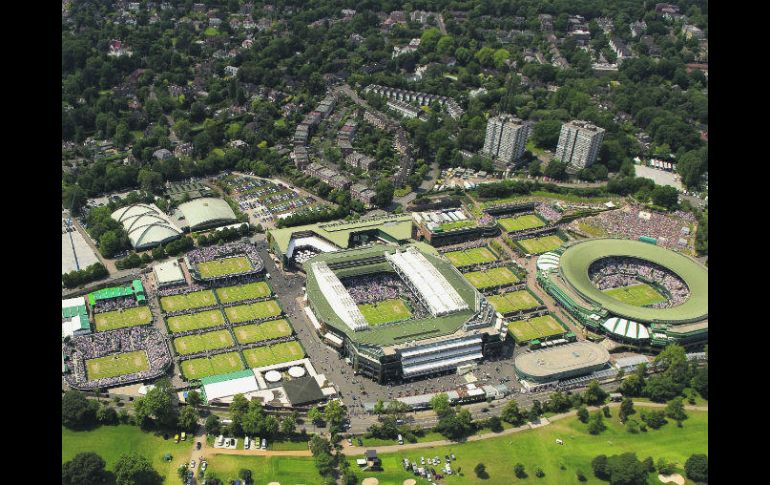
[268,214,412,254]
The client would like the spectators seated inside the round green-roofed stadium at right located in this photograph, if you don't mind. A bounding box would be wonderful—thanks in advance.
[588,257,690,308]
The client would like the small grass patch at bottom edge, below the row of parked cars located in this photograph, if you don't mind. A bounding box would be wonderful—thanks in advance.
[206,452,323,485]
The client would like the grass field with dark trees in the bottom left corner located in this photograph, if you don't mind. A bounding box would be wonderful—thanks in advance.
[61,424,190,485]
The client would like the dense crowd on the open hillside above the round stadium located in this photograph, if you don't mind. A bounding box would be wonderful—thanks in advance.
[585,206,695,247]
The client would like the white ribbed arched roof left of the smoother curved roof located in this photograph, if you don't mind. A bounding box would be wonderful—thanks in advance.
[111,204,182,249]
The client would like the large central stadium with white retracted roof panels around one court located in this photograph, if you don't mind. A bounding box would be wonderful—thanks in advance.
[304,244,505,383]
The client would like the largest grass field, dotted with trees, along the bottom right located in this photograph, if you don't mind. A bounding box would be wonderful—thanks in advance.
[350,408,708,485]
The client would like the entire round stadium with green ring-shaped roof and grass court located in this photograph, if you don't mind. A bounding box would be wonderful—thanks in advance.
[537,239,708,346]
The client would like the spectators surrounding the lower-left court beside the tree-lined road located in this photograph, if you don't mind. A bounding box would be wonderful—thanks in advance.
[62,326,171,389]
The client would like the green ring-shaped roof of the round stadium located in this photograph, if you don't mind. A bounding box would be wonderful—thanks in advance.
[559,239,708,323]
